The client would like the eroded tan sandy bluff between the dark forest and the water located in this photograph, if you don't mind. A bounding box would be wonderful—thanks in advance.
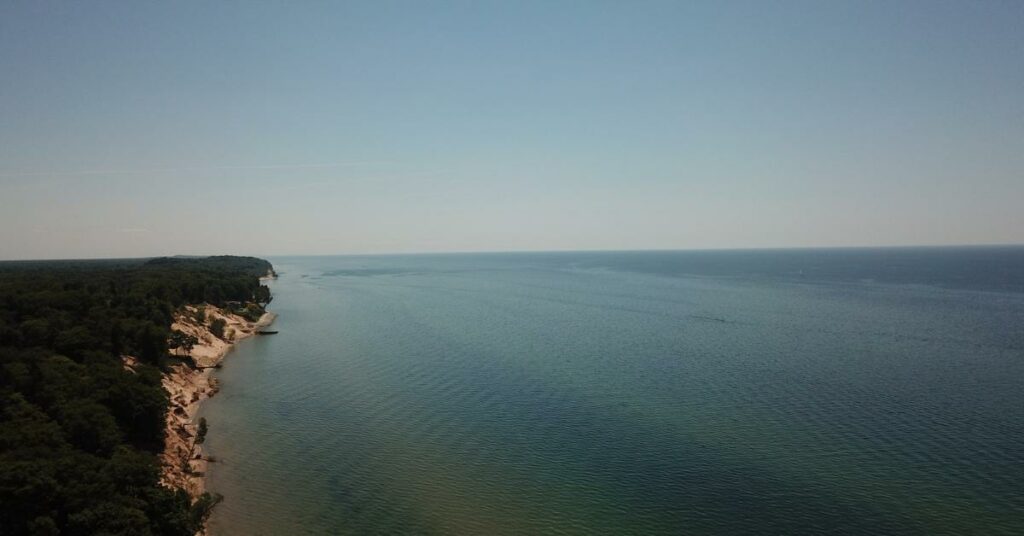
[160,304,276,501]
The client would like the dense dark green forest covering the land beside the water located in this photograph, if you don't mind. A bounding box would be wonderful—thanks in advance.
[0,256,272,535]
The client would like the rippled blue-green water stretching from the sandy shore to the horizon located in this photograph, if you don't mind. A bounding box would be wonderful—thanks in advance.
[203,248,1024,535]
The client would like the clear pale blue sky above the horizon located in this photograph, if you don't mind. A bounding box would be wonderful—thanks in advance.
[0,0,1024,258]
